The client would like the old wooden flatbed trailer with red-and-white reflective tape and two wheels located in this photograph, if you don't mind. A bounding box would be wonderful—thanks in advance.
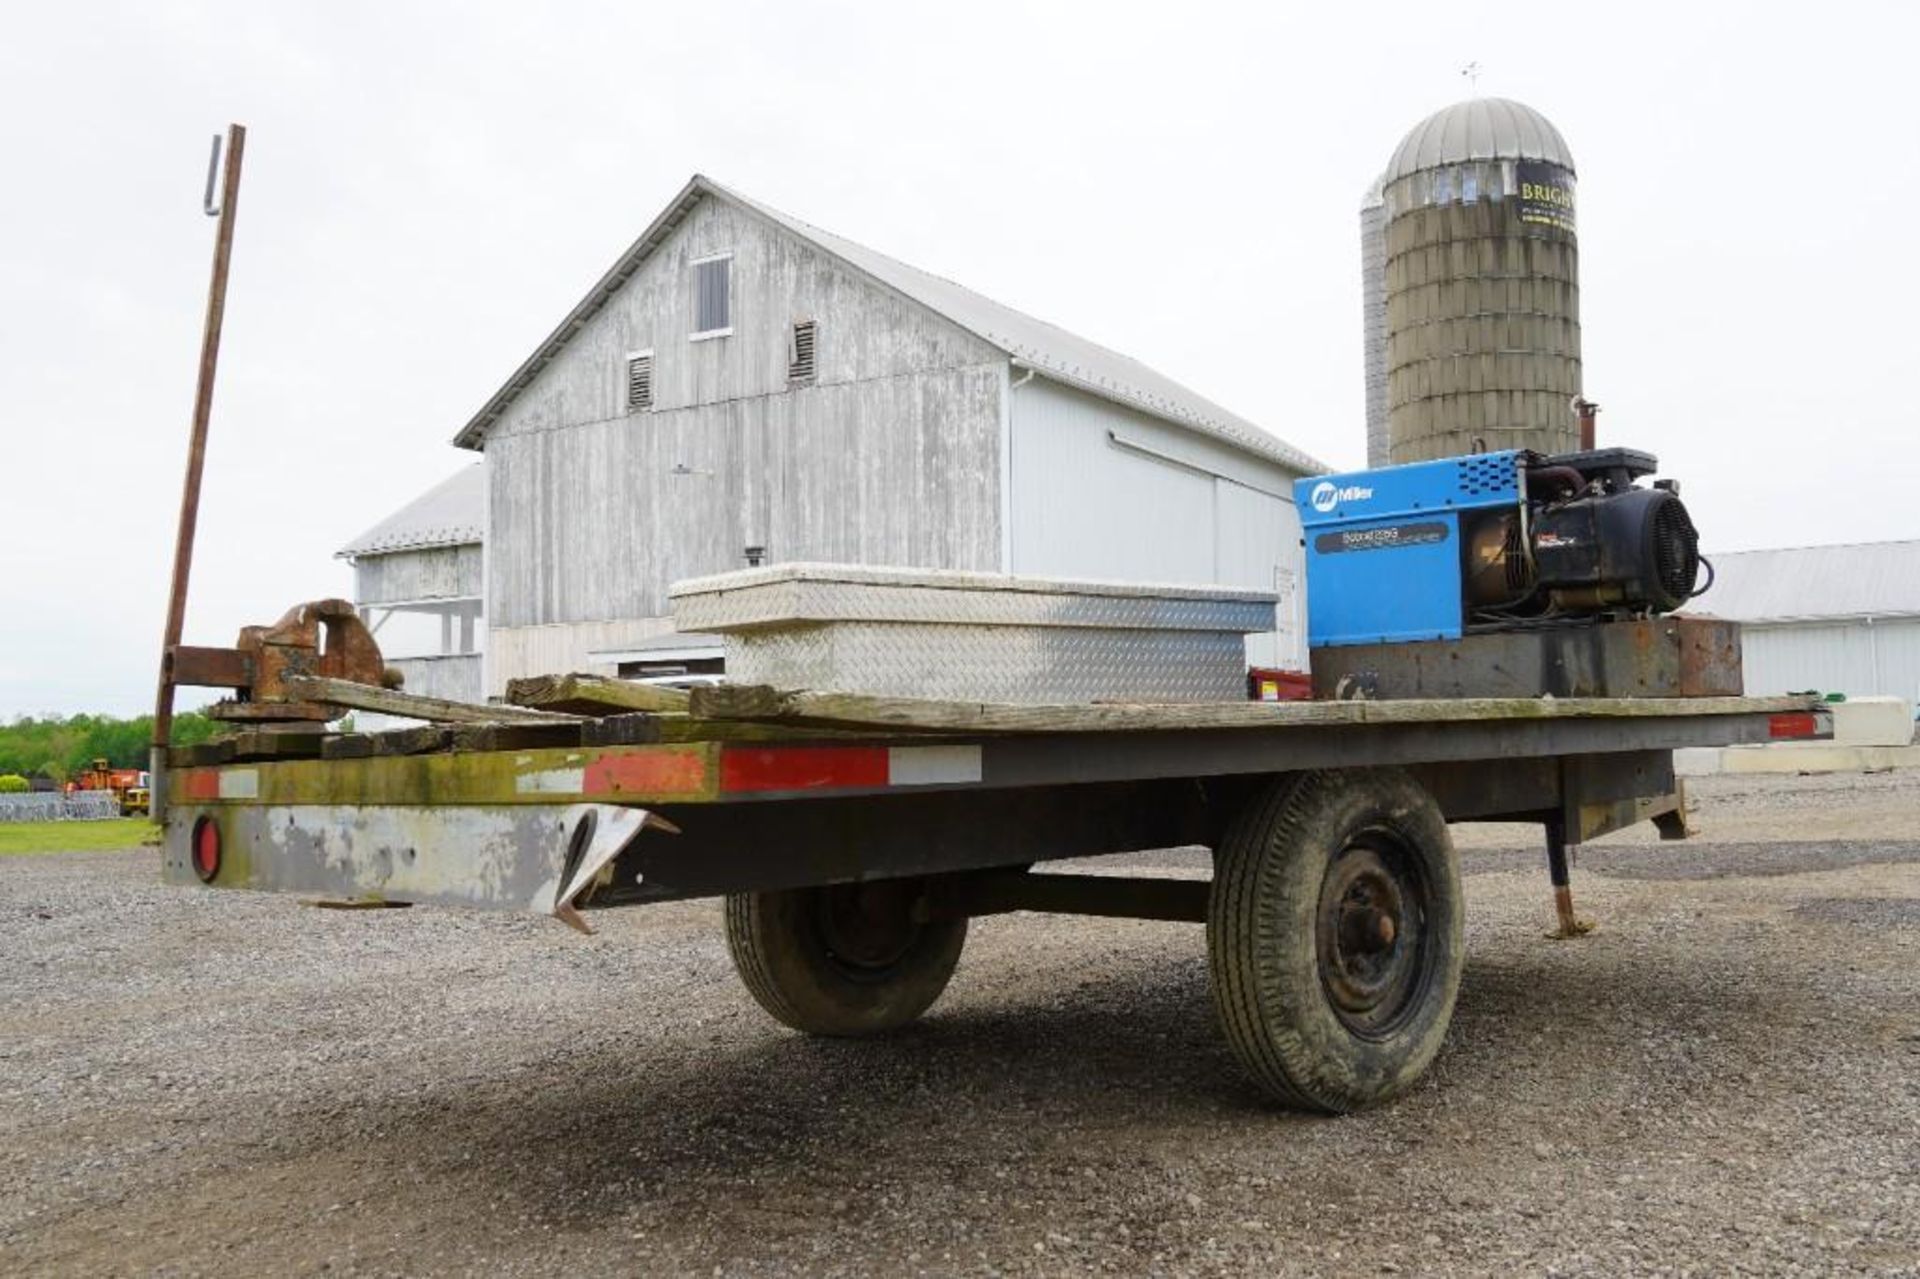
[163,686,1832,1112]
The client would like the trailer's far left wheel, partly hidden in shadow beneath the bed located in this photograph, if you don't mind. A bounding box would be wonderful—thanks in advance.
[726,880,966,1035]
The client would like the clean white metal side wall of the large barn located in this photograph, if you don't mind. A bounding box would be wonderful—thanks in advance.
[1010,376,1306,668]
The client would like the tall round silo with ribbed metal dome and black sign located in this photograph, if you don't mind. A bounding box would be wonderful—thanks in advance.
[1361,98,1580,465]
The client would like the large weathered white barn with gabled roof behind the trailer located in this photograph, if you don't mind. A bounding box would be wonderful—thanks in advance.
[441,177,1325,691]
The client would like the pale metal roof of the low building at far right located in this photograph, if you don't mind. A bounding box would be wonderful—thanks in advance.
[1695,542,1920,622]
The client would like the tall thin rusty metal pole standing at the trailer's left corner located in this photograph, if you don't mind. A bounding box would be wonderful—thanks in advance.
[148,125,246,822]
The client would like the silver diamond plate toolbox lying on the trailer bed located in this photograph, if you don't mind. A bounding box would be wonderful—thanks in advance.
[672,565,1275,703]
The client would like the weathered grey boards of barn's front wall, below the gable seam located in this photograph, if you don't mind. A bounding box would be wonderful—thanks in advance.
[488,367,1000,628]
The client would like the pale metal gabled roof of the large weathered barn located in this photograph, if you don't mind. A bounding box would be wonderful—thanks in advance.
[453,175,1329,474]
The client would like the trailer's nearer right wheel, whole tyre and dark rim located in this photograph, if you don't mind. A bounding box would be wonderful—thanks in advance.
[1208,768,1465,1114]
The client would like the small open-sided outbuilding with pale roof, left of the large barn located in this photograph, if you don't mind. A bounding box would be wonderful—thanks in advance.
[338,463,486,701]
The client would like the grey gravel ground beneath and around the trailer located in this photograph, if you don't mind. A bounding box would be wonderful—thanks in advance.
[0,760,1920,1275]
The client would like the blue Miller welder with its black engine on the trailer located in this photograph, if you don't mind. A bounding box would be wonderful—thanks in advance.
[1296,447,1711,645]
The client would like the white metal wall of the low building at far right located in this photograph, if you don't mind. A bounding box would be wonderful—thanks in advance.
[1740,618,1920,701]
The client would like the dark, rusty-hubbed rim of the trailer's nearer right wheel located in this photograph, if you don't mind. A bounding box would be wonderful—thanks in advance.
[1313,830,1432,1039]
